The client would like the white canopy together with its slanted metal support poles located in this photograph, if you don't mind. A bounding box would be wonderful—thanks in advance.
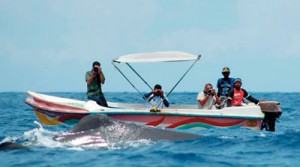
[112,51,201,97]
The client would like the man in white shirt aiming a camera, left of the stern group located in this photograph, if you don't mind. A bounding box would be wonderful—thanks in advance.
[197,83,221,109]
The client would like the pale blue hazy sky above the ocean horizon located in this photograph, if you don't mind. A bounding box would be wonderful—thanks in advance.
[0,0,300,92]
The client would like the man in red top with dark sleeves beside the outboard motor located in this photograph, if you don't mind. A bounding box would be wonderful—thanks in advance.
[227,78,259,106]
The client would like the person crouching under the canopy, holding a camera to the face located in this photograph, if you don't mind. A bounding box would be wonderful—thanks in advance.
[144,84,170,109]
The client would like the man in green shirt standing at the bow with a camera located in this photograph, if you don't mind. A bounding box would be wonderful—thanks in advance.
[85,61,108,107]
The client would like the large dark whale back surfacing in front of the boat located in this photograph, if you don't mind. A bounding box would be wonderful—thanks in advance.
[54,115,201,142]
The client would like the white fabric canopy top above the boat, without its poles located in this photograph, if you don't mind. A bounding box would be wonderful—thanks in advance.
[113,51,200,63]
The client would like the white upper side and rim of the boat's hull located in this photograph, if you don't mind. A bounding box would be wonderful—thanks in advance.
[25,93,265,119]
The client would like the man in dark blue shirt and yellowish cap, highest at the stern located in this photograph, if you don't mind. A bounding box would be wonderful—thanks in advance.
[217,67,235,107]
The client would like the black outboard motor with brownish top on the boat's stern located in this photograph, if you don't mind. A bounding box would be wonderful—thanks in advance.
[259,101,282,132]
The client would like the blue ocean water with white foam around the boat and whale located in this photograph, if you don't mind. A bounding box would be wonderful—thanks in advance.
[0,92,300,167]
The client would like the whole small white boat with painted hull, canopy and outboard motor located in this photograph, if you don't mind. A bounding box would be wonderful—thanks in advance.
[25,52,281,131]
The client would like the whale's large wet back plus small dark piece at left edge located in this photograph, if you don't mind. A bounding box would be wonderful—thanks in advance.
[0,115,201,151]
